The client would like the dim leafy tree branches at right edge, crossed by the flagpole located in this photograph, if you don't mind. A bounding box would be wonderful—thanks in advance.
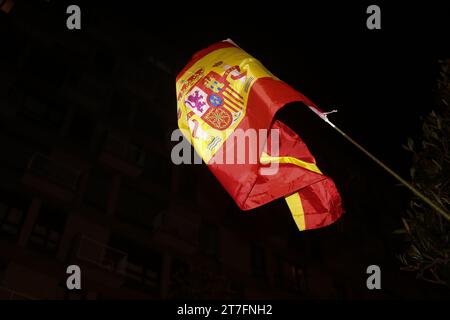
[395,60,450,286]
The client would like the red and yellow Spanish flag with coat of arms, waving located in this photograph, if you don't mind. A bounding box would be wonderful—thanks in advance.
[176,40,343,231]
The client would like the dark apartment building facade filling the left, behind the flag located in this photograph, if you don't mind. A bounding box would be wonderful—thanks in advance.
[0,1,324,299]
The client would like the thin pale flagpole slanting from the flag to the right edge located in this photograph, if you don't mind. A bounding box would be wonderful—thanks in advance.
[308,106,450,221]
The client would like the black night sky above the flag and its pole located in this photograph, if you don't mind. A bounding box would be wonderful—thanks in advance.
[93,2,449,174]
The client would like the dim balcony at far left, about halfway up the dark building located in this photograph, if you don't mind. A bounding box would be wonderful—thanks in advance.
[22,153,82,202]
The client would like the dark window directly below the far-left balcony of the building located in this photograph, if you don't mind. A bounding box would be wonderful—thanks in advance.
[28,204,67,255]
